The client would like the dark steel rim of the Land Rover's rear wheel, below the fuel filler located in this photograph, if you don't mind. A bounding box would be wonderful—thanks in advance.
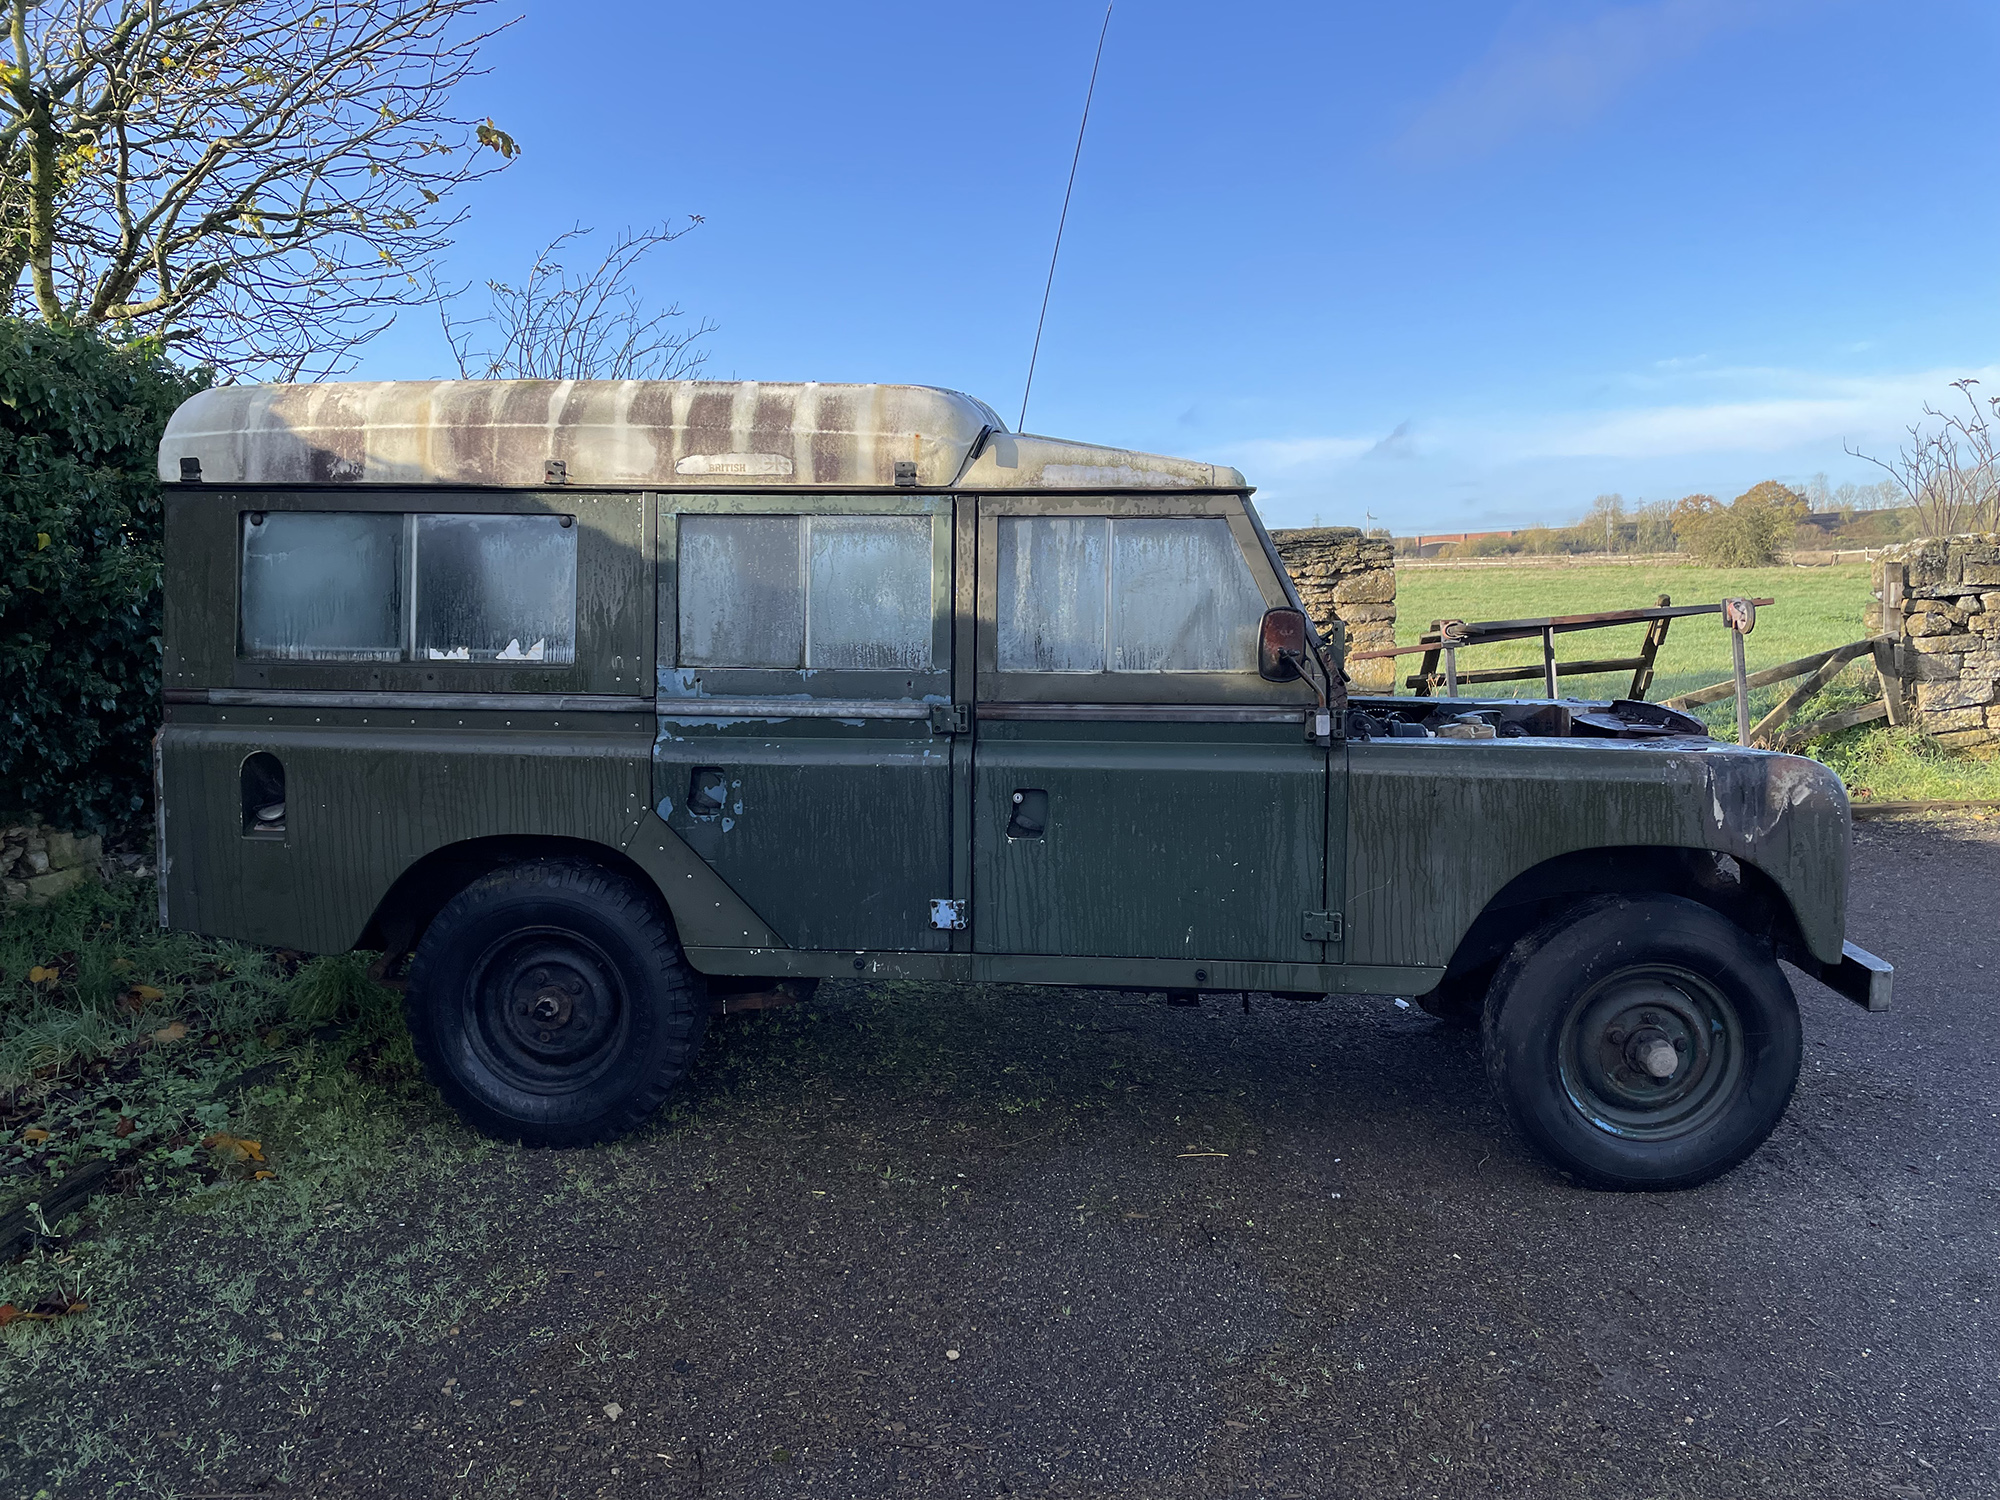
[464,928,632,1094]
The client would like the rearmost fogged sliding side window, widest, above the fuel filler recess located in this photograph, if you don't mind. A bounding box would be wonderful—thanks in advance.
[238,510,576,666]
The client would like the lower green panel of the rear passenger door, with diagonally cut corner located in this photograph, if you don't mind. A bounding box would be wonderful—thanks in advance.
[652,714,952,952]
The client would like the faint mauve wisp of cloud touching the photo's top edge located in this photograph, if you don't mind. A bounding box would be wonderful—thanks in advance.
[1396,0,1782,162]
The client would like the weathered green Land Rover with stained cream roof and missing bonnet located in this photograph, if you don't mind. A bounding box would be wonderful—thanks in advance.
[158,380,1890,1188]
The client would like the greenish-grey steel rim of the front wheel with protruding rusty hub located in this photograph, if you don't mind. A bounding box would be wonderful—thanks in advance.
[1556,964,1746,1142]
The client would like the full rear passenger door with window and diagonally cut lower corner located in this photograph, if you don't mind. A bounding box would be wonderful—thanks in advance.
[654,494,952,952]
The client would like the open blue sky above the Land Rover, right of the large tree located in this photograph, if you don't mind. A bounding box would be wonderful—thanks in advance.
[358,0,2000,532]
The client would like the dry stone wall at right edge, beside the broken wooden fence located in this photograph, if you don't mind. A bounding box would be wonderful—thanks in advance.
[1870,532,2000,754]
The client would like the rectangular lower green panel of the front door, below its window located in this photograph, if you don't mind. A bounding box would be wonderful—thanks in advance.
[972,722,1328,964]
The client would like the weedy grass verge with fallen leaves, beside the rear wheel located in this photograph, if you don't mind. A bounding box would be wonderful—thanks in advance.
[0,882,538,1494]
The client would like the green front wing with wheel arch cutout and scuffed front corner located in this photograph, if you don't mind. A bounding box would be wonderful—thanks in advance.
[1346,738,1848,964]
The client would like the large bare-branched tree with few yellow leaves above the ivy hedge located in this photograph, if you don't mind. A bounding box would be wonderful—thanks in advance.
[0,0,518,380]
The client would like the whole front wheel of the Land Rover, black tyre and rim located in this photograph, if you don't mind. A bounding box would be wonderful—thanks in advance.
[1484,896,1800,1190]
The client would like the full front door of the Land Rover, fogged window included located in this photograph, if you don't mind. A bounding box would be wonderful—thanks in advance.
[972,496,1346,964]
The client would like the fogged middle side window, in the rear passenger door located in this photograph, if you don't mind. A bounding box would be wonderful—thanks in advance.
[676,516,932,672]
